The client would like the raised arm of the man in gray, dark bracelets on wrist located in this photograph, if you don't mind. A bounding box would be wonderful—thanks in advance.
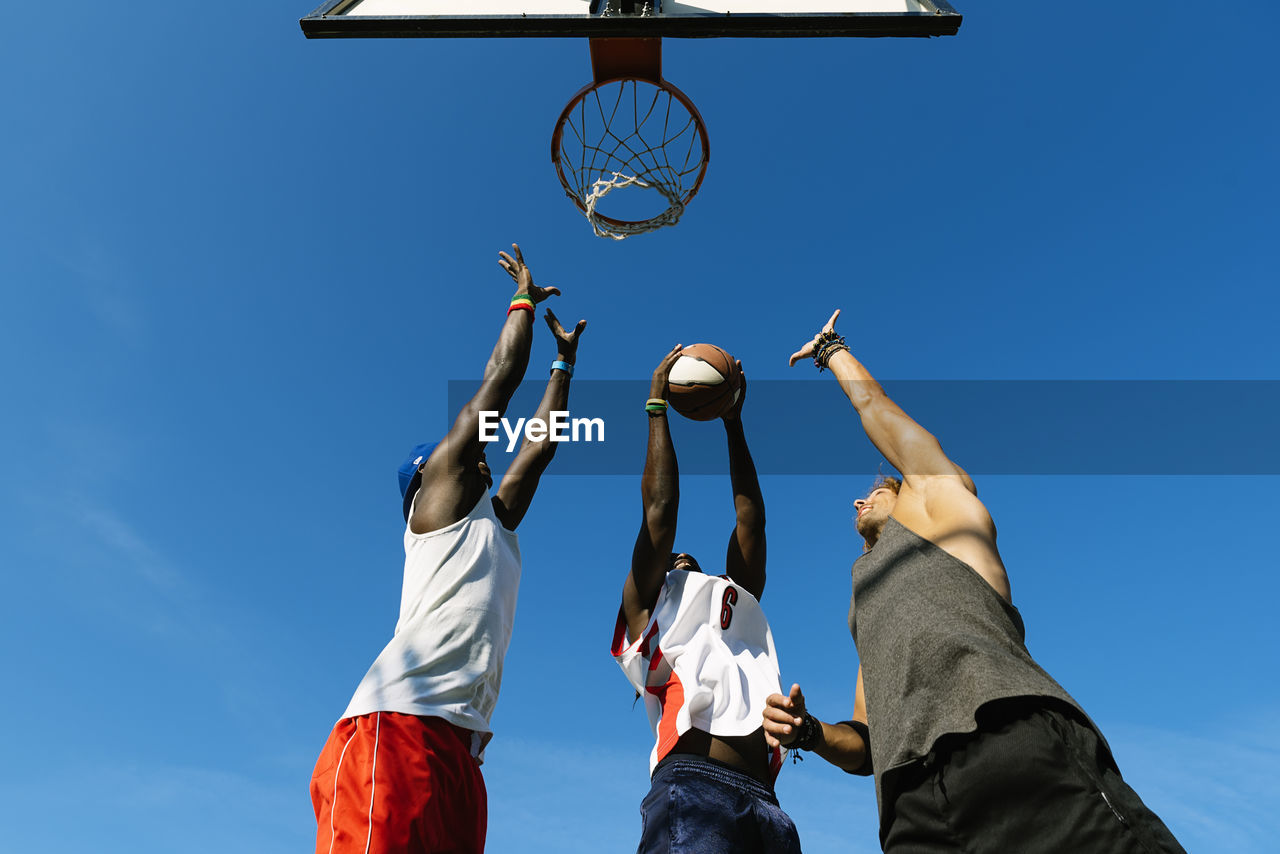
[790,309,977,493]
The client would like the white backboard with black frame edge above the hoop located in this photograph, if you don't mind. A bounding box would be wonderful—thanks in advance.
[301,0,961,38]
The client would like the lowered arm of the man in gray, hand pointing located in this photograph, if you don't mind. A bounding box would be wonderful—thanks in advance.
[764,667,872,776]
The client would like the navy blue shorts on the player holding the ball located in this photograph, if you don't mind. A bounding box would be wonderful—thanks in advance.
[636,754,800,854]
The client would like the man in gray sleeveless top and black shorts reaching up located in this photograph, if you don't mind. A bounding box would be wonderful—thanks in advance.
[764,311,1183,854]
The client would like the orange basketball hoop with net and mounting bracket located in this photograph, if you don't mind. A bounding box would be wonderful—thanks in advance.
[552,38,710,241]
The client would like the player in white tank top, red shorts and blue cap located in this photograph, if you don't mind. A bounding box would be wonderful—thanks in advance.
[311,245,586,854]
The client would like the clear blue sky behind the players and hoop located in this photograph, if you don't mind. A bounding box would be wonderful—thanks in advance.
[0,0,1280,854]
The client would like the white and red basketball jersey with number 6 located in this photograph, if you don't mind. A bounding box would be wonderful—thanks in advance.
[613,570,782,776]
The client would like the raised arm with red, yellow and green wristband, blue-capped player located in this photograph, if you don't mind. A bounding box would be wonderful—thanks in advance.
[410,243,559,534]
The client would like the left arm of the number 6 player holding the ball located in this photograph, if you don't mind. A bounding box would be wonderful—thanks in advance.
[622,344,681,641]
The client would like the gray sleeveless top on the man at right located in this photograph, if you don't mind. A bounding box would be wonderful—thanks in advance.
[849,517,1096,814]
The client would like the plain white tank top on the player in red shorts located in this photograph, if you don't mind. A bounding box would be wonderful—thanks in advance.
[343,492,520,759]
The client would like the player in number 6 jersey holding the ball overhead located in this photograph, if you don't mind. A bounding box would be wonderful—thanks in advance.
[613,344,800,854]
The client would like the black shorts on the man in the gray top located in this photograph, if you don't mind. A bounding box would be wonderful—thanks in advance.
[881,698,1185,854]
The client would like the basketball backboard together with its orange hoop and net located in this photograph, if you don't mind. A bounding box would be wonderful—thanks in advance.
[301,0,961,239]
